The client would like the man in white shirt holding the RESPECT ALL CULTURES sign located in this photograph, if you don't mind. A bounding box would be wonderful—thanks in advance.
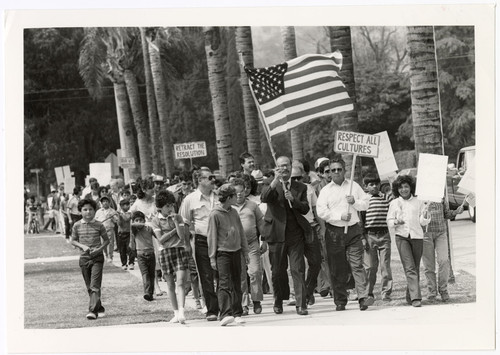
[316,156,373,311]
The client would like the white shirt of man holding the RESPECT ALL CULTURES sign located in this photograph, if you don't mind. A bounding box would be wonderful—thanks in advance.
[316,180,370,227]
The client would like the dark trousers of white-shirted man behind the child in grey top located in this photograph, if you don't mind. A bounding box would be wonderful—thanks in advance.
[194,234,219,316]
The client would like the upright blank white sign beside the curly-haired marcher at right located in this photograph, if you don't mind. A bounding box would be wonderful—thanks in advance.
[415,153,448,202]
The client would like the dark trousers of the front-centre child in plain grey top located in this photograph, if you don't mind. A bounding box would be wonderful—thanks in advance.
[217,250,243,319]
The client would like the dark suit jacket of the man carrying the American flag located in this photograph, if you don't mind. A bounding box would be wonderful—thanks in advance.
[260,180,313,243]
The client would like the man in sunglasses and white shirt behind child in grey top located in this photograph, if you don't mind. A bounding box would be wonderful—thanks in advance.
[179,168,219,321]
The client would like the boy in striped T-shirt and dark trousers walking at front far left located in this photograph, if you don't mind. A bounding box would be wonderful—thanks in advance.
[71,199,109,320]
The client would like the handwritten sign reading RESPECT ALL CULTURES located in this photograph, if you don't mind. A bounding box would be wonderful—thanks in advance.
[334,131,380,158]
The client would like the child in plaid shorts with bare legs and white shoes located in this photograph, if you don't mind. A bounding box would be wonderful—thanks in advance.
[151,190,191,324]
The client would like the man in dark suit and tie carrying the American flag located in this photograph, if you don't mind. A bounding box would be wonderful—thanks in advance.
[261,156,312,315]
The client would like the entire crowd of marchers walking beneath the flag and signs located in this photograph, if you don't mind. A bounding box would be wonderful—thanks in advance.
[22,153,463,326]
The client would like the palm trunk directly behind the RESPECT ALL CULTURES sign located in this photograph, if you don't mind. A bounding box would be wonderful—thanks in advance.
[328,26,361,180]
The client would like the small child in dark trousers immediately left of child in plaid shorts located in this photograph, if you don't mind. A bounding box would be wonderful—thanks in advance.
[130,211,156,301]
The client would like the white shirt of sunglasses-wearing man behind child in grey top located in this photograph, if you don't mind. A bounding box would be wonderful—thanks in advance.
[179,189,216,236]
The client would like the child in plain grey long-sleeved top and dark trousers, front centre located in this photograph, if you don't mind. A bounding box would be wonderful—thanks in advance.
[207,184,248,326]
